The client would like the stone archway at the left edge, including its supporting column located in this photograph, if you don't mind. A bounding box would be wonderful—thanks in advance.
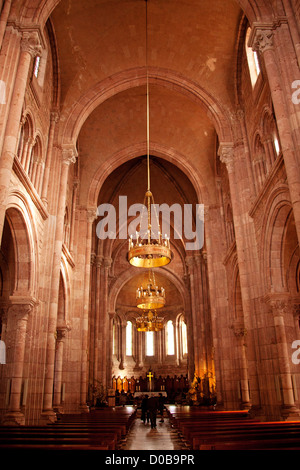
[0,207,36,425]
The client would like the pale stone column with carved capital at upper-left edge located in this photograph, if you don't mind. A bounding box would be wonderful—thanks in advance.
[0,31,41,238]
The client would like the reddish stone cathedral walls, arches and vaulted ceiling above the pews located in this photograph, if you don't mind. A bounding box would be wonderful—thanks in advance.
[0,0,300,432]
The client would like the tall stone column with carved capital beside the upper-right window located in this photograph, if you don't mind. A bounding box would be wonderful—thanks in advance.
[250,25,300,246]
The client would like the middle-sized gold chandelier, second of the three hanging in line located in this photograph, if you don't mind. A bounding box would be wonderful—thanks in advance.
[136,273,166,310]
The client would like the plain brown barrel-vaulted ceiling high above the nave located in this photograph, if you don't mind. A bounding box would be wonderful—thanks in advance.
[51,0,242,204]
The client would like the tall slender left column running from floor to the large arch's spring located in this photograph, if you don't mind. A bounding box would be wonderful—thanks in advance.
[42,146,76,422]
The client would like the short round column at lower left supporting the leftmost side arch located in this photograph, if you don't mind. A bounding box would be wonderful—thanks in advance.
[2,299,34,426]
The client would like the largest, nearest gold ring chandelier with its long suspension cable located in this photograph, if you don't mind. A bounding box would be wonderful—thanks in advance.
[128,0,172,268]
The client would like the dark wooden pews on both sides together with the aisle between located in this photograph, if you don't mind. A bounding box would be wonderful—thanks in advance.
[0,405,300,453]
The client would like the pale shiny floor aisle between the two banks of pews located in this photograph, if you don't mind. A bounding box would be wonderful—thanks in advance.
[120,410,187,451]
